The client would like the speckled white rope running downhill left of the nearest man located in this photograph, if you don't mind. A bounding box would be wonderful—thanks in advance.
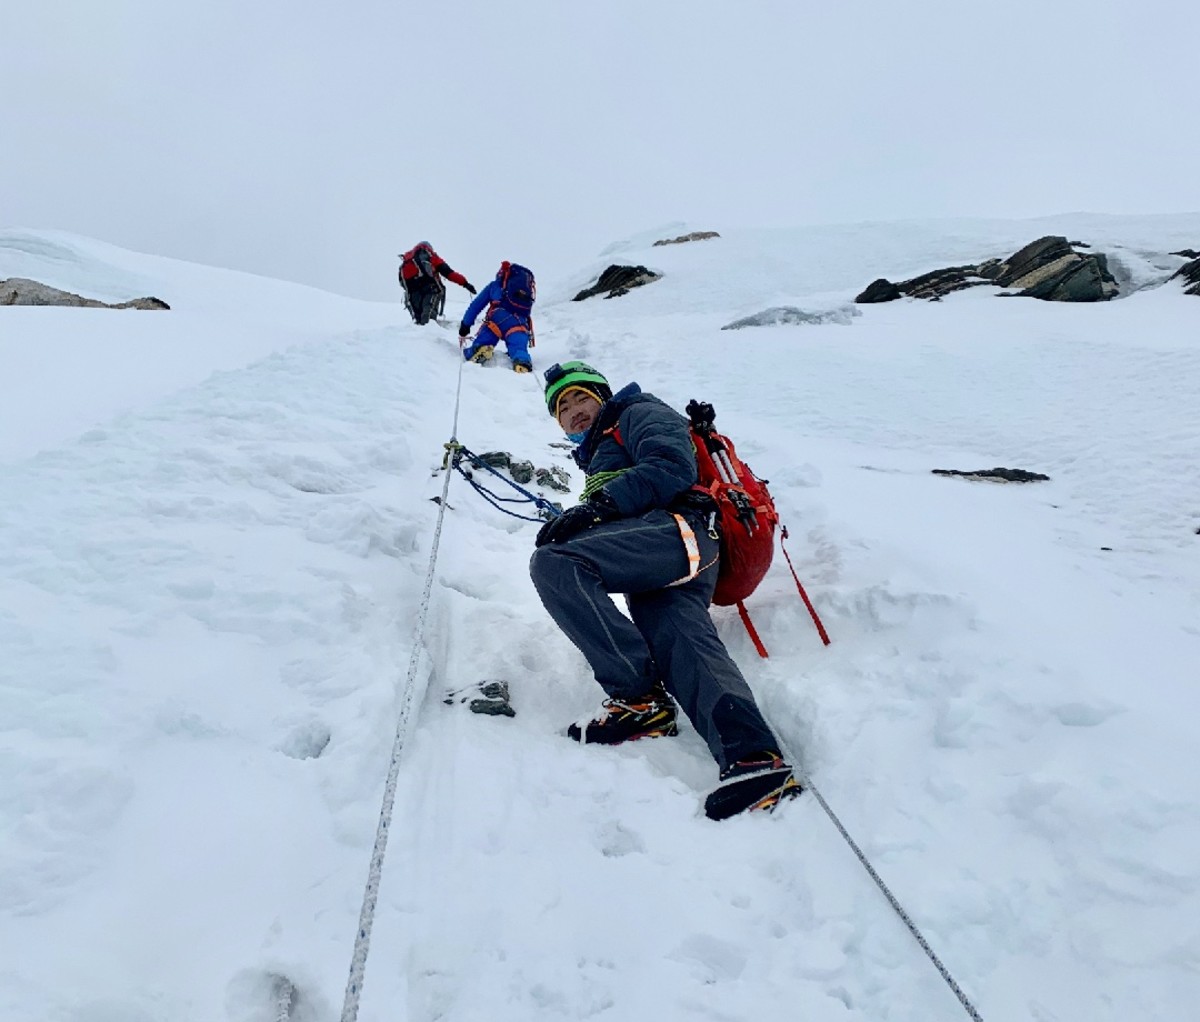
[341,359,466,1022]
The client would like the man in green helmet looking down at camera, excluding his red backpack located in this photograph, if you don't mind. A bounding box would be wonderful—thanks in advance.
[529,362,799,814]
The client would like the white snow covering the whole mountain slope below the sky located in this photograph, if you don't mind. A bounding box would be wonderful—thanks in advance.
[0,221,1200,1022]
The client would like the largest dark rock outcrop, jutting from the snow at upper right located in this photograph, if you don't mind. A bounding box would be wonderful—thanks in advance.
[854,236,1117,305]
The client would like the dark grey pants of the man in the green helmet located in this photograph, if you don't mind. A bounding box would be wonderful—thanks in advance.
[529,511,779,770]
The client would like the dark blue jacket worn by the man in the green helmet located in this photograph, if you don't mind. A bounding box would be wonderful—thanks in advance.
[575,383,697,516]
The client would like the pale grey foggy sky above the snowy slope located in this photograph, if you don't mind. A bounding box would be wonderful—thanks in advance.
[0,0,1200,300]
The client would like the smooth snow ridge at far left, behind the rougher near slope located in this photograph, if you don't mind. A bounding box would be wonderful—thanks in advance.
[0,230,408,461]
